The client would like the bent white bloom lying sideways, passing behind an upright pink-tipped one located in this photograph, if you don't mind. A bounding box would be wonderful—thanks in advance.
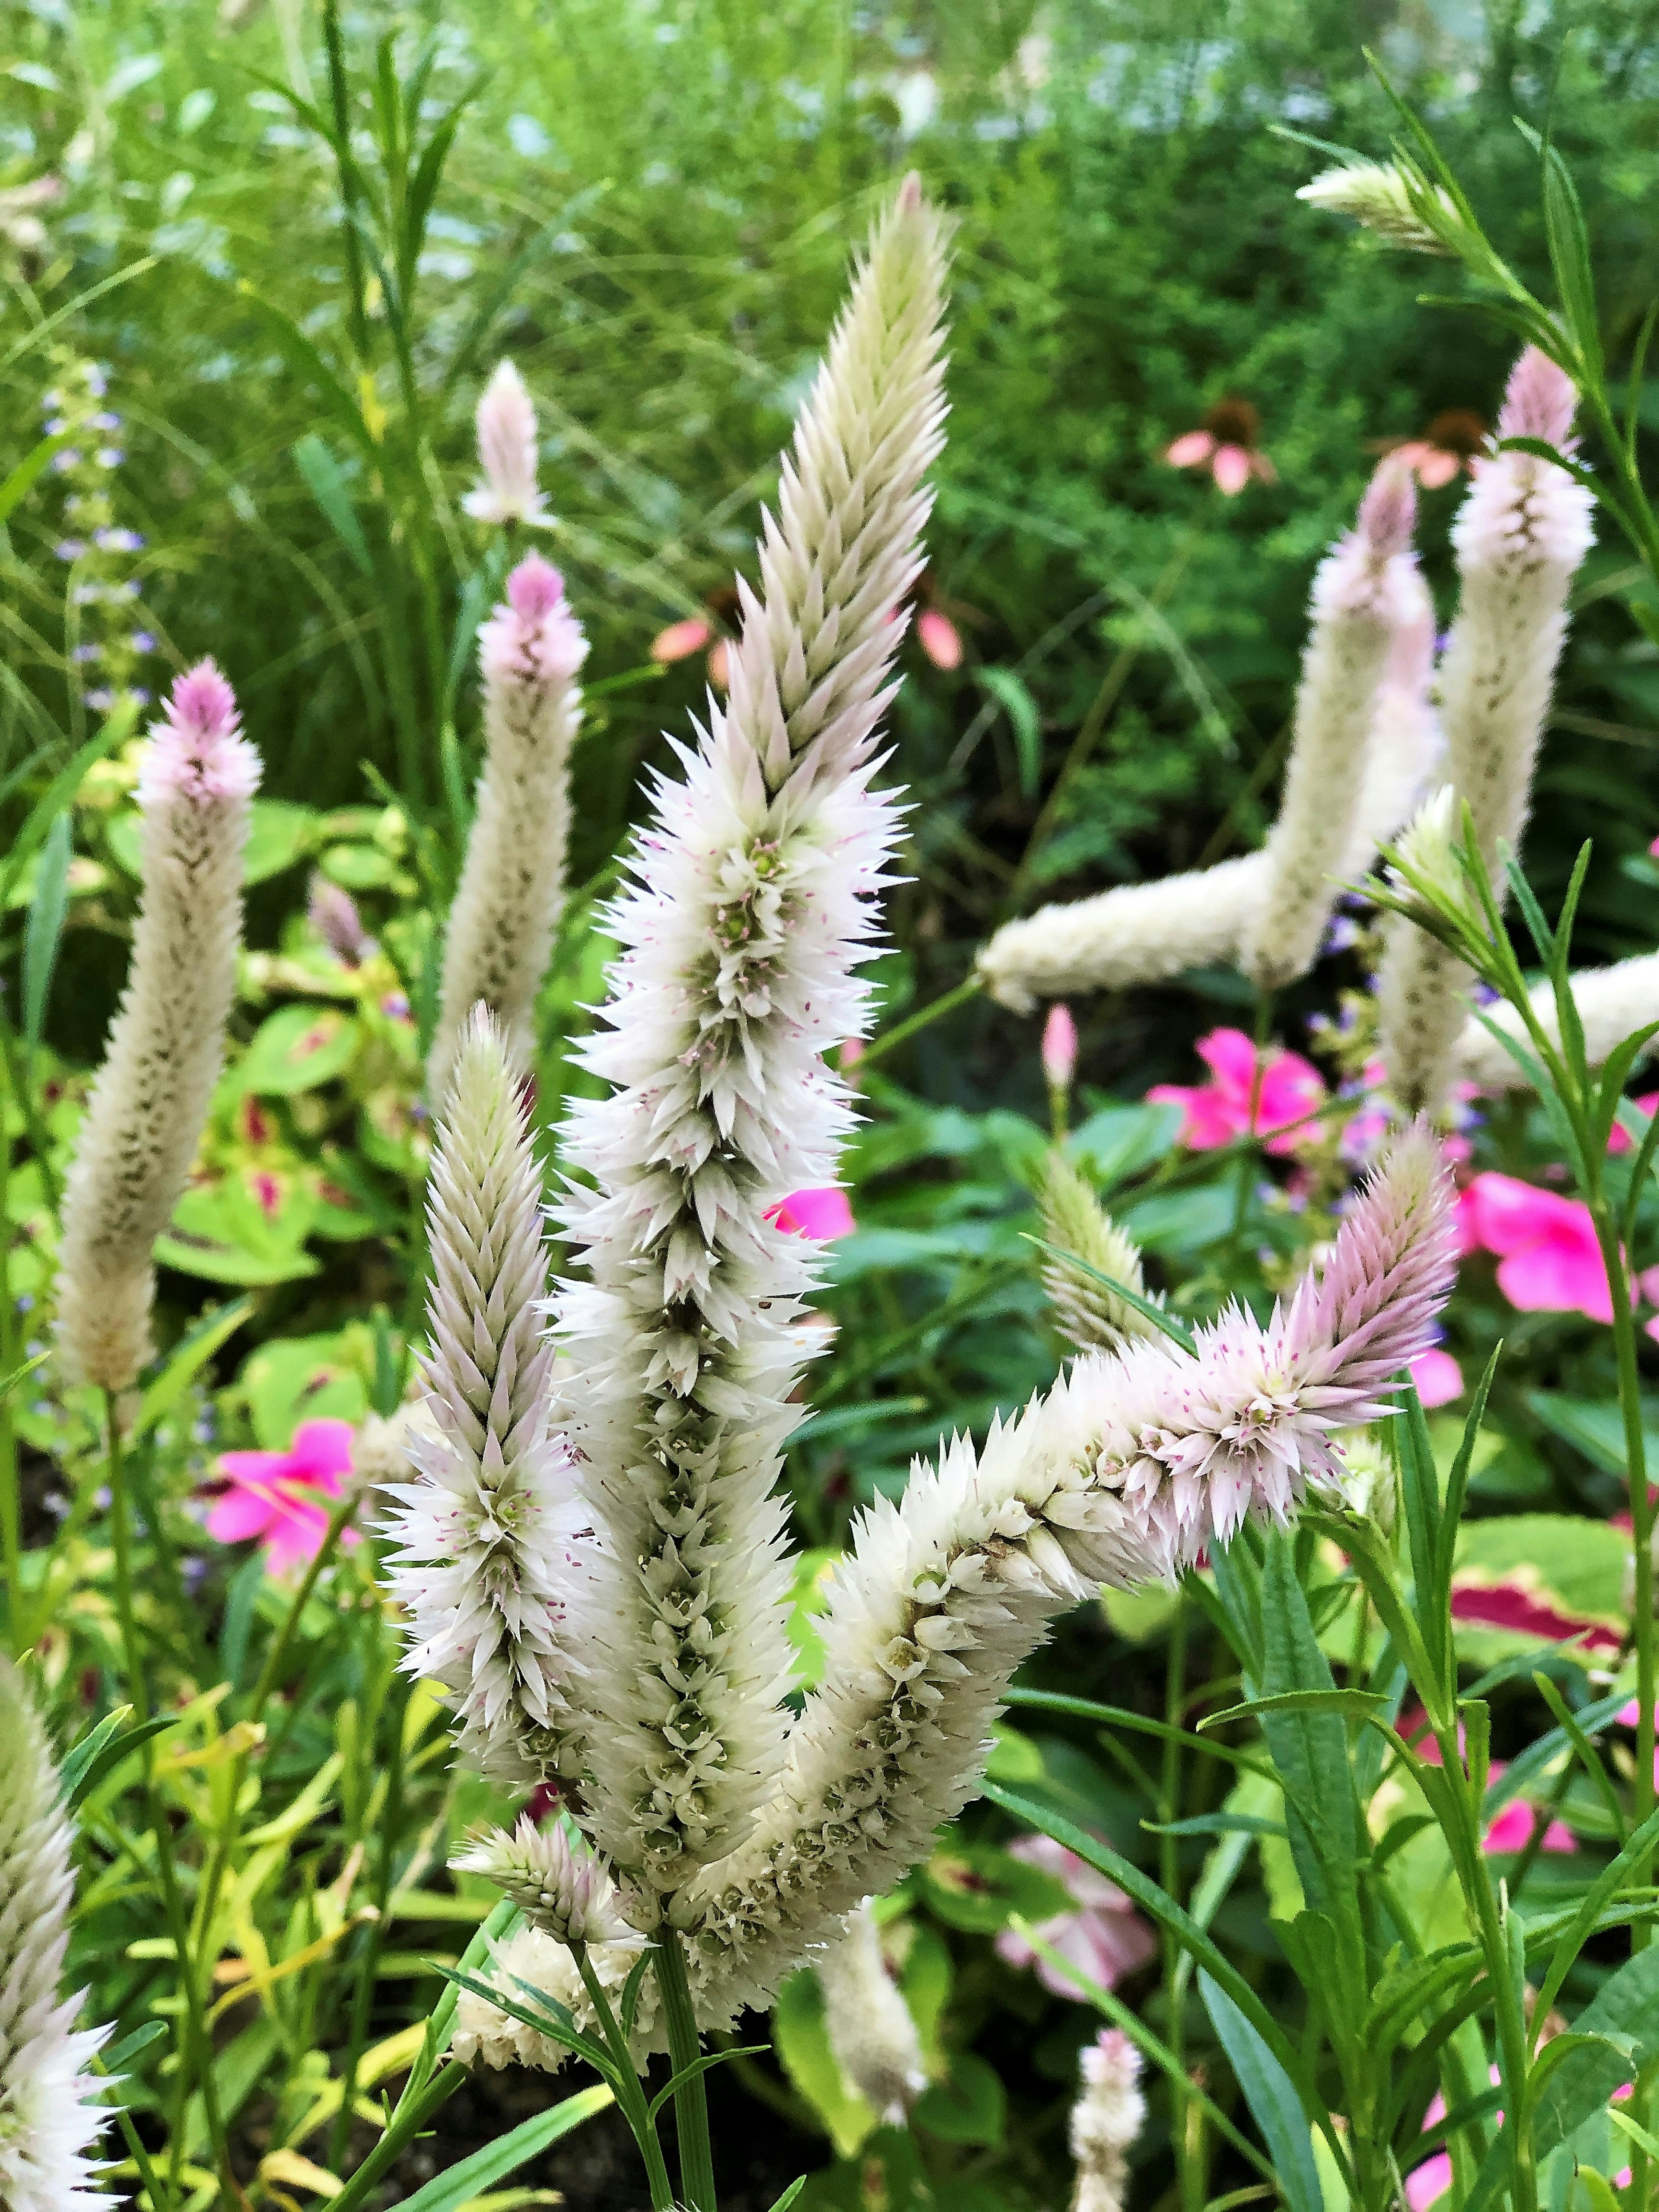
[976,484,1440,1013]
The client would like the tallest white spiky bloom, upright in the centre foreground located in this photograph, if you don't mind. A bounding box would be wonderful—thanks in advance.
[557,179,944,1889]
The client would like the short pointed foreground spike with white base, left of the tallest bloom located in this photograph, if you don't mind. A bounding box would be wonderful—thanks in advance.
[385,1007,591,1783]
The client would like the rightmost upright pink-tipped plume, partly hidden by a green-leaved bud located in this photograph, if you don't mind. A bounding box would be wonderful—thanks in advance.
[1378,345,1592,1108]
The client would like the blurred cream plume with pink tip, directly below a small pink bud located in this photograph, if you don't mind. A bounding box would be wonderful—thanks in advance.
[427,553,588,1100]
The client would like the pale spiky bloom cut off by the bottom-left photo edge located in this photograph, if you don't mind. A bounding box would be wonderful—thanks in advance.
[0,1657,111,2212]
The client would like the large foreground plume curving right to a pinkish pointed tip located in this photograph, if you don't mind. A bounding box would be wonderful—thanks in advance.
[672,1126,1458,2022]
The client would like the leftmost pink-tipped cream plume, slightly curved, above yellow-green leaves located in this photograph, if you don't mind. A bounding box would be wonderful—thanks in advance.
[57,661,259,1391]
